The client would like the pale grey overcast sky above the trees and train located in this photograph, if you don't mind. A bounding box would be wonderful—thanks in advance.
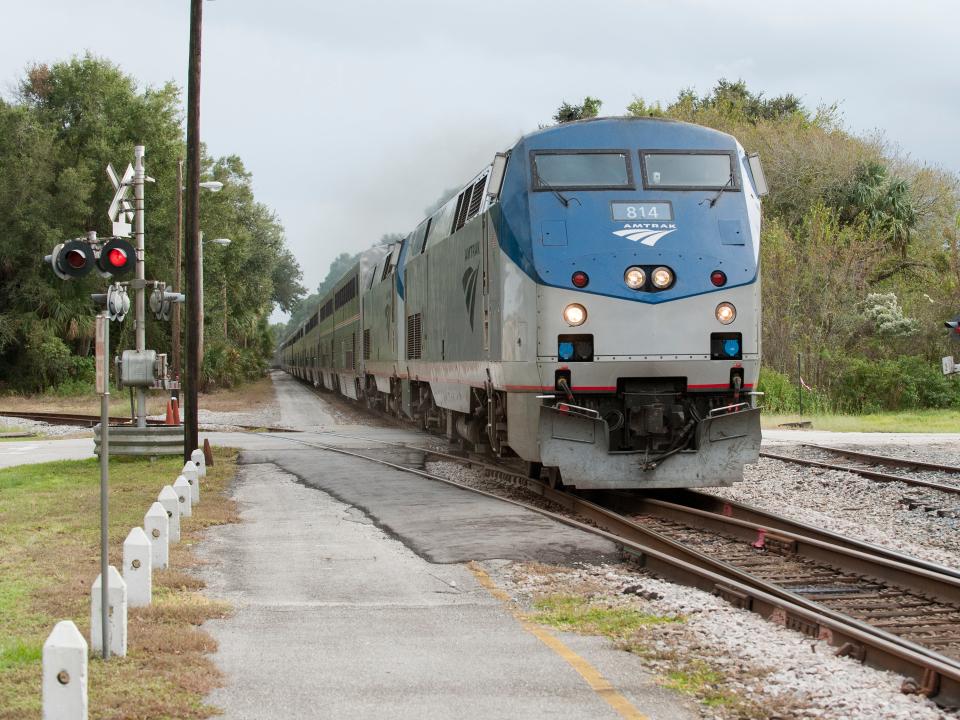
[0,0,960,320]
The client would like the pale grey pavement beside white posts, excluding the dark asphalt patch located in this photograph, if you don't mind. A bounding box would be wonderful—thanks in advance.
[201,464,699,720]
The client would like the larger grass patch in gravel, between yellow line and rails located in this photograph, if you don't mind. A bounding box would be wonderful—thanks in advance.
[530,595,682,639]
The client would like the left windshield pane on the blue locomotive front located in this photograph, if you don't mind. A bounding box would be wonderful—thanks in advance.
[531,150,633,190]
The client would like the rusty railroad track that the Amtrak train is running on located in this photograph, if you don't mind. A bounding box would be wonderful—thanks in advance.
[262,432,960,706]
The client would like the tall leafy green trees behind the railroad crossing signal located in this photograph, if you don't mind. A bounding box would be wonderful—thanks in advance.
[0,54,303,390]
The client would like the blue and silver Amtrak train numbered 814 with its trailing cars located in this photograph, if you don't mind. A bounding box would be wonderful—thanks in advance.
[280,118,766,489]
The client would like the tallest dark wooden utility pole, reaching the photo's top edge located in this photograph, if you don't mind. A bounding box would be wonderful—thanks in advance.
[183,0,203,461]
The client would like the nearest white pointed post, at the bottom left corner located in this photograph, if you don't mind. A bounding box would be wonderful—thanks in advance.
[43,618,87,720]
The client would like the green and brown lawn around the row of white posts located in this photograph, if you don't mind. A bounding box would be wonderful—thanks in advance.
[0,449,237,720]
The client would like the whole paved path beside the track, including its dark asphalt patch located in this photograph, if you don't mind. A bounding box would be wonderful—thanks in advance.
[202,377,698,720]
